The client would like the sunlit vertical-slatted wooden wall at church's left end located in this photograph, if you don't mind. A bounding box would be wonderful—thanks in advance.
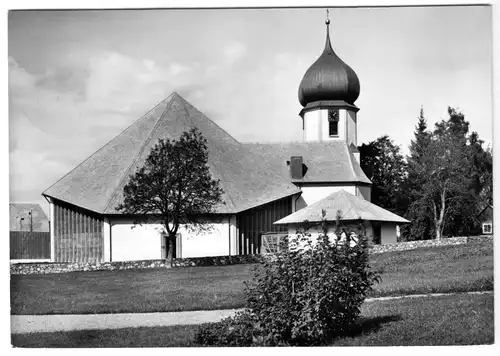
[52,199,104,262]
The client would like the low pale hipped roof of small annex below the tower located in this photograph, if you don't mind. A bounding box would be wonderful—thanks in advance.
[275,189,409,224]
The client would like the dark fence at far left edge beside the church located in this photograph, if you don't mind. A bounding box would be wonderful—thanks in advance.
[10,231,50,260]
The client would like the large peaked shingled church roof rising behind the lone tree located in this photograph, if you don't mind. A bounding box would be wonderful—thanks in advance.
[43,93,300,214]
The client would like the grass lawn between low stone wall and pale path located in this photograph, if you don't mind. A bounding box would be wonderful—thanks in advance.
[11,242,493,314]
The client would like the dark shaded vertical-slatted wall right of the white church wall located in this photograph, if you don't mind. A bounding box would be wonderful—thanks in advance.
[236,197,292,255]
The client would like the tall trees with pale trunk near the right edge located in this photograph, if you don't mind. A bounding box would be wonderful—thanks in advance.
[403,107,492,239]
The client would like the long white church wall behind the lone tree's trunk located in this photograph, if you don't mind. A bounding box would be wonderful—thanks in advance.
[105,216,232,261]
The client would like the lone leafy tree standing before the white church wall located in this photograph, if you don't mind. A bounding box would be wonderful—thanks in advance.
[118,128,222,256]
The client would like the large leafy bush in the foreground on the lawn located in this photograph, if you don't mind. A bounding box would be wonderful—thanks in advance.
[197,218,379,346]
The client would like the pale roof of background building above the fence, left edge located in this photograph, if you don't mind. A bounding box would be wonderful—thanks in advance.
[9,203,49,232]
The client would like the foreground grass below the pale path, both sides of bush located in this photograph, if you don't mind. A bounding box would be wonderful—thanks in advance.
[12,294,494,347]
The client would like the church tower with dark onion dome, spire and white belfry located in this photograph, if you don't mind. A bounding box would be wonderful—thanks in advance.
[299,10,360,147]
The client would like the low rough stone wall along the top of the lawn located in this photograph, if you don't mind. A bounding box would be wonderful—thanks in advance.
[10,235,493,275]
